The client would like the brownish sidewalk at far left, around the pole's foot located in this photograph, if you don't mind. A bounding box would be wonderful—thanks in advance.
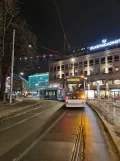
[0,99,40,118]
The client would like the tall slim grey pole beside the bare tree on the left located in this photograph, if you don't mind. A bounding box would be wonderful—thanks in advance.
[9,30,15,103]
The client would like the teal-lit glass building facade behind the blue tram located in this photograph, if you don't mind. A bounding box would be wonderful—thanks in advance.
[29,73,49,91]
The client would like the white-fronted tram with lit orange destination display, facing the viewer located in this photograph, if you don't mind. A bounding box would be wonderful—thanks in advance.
[65,76,86,107]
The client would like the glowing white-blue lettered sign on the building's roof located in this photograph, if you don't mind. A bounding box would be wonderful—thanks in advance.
[90,39,120,50]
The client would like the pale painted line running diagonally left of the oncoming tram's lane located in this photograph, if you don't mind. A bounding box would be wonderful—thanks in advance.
[15,111,66,161]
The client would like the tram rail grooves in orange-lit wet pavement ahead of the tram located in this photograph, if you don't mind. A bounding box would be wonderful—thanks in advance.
[71,114,85,161]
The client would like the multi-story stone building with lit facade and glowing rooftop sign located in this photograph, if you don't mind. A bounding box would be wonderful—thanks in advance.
[49,39,120,96]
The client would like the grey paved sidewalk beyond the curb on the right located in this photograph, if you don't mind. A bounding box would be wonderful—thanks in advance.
[87,100,120,135]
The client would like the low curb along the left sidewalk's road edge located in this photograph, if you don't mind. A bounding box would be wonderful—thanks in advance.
[0,102,40,120]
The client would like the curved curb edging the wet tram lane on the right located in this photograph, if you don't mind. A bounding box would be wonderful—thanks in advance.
[87,102,120,157]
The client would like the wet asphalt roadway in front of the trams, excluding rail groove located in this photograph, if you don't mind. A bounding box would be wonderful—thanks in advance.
[0,101,120,161]
